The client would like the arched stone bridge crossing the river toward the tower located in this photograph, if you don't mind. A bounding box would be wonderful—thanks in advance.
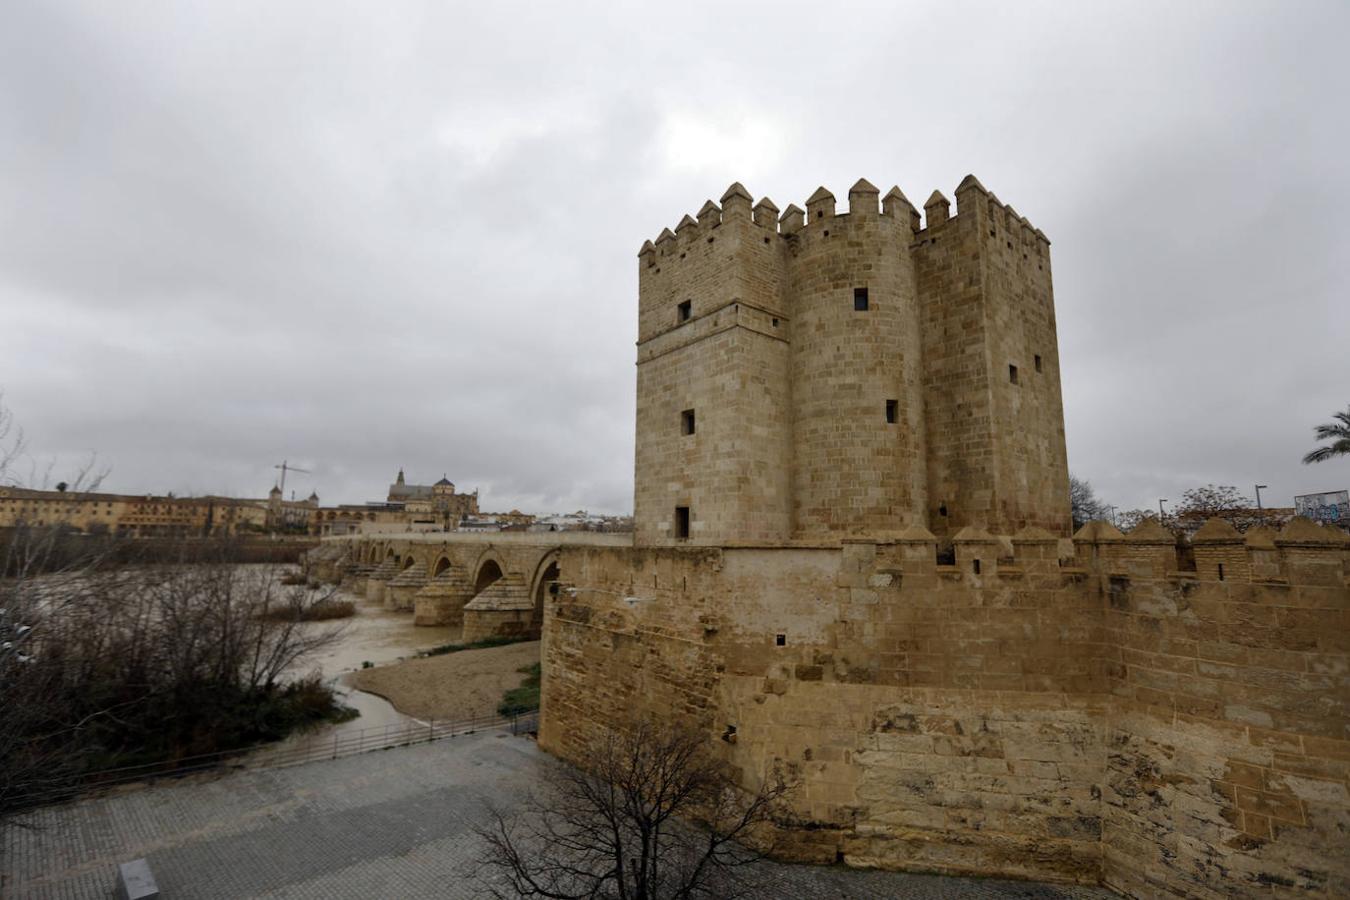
[305,532,633,642]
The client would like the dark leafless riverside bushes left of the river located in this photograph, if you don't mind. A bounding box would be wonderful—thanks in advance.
[0,528,355,823]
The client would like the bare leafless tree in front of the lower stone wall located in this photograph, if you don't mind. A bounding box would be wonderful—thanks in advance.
[477,721,795,900]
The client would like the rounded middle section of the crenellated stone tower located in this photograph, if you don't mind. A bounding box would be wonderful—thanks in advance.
[787,182,927,540]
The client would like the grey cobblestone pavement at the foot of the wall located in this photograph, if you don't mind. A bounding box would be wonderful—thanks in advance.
[0,731,1114,900]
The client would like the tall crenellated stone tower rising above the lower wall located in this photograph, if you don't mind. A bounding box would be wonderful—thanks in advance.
[635,175,1069,545]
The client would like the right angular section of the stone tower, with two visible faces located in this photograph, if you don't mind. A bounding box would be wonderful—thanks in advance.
[913,175,1069,537]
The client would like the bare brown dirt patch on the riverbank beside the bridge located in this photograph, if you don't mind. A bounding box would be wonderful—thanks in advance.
[354,641,539,719]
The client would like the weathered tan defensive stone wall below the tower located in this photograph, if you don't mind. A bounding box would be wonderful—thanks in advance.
[540,519,1350,897]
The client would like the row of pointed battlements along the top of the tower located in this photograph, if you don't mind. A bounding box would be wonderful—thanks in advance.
[639,175,1050,256]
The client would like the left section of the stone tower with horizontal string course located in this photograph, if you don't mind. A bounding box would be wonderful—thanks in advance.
[633,185,791,544]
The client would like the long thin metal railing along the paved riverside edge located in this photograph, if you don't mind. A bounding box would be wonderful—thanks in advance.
[7,710,539,808]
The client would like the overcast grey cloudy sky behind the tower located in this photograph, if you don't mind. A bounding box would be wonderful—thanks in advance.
[0,0,1350,511]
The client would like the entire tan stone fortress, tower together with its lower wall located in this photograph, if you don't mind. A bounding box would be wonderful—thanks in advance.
[540,177,1350,899]
